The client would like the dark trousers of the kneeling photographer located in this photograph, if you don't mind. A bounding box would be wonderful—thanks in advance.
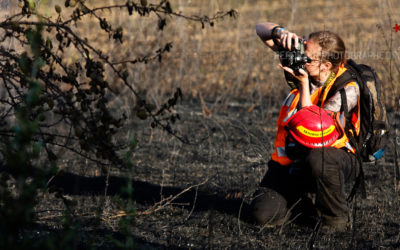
[251,147,359,224]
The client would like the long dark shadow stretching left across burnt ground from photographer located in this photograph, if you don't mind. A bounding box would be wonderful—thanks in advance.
[49,173,253,221]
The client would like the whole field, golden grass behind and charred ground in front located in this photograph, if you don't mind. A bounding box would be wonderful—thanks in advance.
[3,0,400,249]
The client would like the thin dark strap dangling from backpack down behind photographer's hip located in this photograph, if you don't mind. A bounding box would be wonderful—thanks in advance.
[340,88,367,202]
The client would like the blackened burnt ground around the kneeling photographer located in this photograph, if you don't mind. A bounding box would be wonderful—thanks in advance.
[34,98,400,249]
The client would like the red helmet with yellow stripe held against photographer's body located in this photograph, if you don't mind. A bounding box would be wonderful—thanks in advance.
[286,105,340,148]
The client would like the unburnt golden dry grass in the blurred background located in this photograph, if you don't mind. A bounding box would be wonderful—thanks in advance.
[3,0,400,109]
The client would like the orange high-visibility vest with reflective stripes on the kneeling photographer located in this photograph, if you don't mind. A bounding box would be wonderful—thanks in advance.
[272,65,360,165]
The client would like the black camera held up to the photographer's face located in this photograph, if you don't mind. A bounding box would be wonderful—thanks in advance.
[279,39,311,73]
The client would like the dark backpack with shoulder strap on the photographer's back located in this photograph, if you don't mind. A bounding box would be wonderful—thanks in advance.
[326,59,391,200]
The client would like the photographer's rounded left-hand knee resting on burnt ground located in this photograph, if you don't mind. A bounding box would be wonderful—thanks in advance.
[251,187,287,225]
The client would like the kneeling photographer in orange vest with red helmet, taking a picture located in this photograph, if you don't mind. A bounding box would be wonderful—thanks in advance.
[251,23,360,231]
